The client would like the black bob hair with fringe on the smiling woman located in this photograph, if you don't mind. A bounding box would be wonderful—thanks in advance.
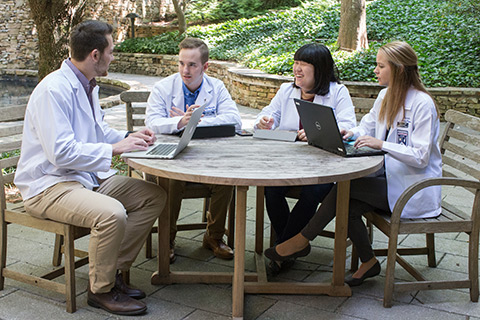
[293,43,340,96]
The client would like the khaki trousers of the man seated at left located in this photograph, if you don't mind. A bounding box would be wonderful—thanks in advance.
[25,176,166,293]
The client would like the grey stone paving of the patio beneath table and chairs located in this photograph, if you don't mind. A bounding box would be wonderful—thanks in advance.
[0,74,480,320]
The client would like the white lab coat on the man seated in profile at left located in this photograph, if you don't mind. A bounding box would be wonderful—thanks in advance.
[15,62,126,200]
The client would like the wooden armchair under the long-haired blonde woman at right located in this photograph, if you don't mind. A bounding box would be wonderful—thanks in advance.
[366,110,480,308]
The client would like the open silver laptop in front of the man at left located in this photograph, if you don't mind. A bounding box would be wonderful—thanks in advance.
[122,105,205,159]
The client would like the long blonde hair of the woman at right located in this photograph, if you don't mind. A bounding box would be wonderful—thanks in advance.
[378,41,439,128]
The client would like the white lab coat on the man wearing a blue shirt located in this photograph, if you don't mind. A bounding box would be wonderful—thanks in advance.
[145,73,242,134]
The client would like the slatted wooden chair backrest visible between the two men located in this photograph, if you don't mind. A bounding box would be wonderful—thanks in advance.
[120,91,150,131]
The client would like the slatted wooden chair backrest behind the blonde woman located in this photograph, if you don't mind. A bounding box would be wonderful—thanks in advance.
[439,110,480,193]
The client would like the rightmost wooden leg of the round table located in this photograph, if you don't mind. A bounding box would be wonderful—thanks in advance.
[332,180,350,288]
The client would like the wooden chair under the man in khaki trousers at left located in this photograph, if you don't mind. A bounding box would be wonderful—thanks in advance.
[0,108,88,312]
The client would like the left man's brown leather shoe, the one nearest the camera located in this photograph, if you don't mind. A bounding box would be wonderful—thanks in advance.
[87,288,147,316]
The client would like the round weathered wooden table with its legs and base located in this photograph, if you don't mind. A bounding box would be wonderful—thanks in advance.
[126,135,383,319]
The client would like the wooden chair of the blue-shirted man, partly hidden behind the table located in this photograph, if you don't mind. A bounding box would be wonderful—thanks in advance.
[120,91,235,258]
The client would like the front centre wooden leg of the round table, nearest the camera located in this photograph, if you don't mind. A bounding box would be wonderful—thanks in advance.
[232,186,248,319]
